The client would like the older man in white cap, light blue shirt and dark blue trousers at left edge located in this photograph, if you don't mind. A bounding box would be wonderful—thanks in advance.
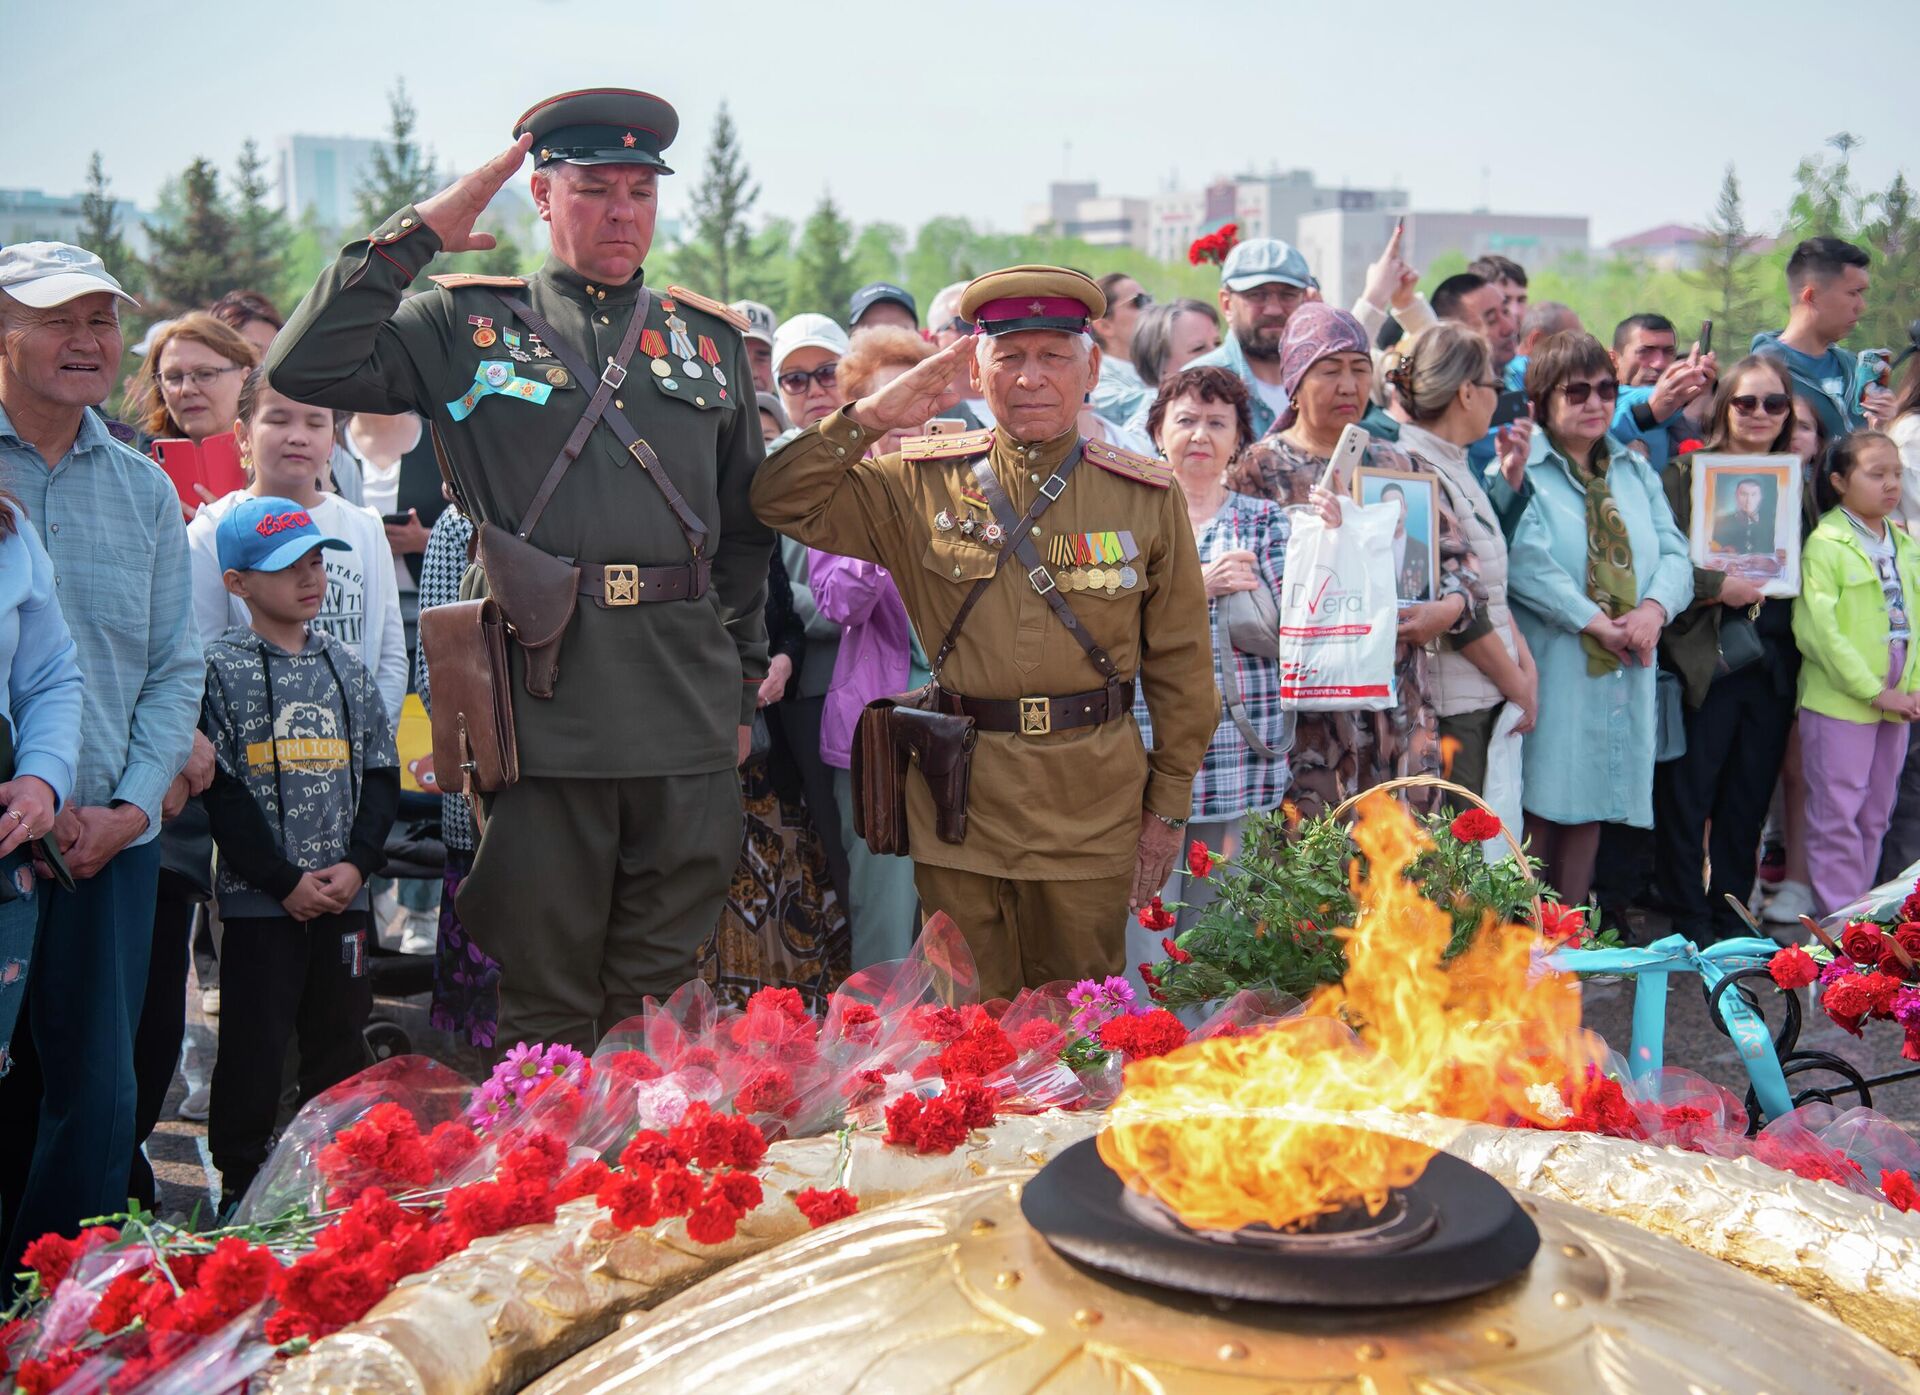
[0,242,211,1272]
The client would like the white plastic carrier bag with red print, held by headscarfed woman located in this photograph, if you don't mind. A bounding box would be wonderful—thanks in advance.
[1281,499,1400,712]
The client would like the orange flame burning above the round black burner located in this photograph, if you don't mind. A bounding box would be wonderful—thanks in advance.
[1100,794,1603,1230]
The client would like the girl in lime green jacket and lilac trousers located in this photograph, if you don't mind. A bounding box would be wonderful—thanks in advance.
[1793,432,1920,915]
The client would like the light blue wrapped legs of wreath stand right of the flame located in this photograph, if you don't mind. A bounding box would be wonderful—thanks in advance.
[1548,934,1793,1119]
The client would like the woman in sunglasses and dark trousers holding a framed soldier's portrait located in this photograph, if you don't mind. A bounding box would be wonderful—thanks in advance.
[1653,355,1799,942]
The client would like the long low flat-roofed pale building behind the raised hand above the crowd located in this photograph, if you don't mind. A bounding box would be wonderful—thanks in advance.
[1297,207,1588,305]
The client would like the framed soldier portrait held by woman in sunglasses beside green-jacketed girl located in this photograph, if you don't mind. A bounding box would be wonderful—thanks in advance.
[1688,455,1801,597]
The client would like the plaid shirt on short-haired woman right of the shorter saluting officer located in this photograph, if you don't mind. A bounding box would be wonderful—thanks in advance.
[1133,493,1292,821]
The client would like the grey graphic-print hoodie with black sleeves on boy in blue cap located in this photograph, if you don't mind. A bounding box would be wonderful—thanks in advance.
[200,626,399,919]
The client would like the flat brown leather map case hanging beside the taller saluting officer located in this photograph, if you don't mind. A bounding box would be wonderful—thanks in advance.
[420,599,520,798]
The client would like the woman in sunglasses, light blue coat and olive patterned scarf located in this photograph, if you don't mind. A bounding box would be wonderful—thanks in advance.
[1490,334,1693,904]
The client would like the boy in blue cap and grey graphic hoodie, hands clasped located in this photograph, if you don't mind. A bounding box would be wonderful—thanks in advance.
[200,495,399,1207]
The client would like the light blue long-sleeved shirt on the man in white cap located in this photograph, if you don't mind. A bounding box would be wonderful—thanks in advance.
[0,411,205,846]
